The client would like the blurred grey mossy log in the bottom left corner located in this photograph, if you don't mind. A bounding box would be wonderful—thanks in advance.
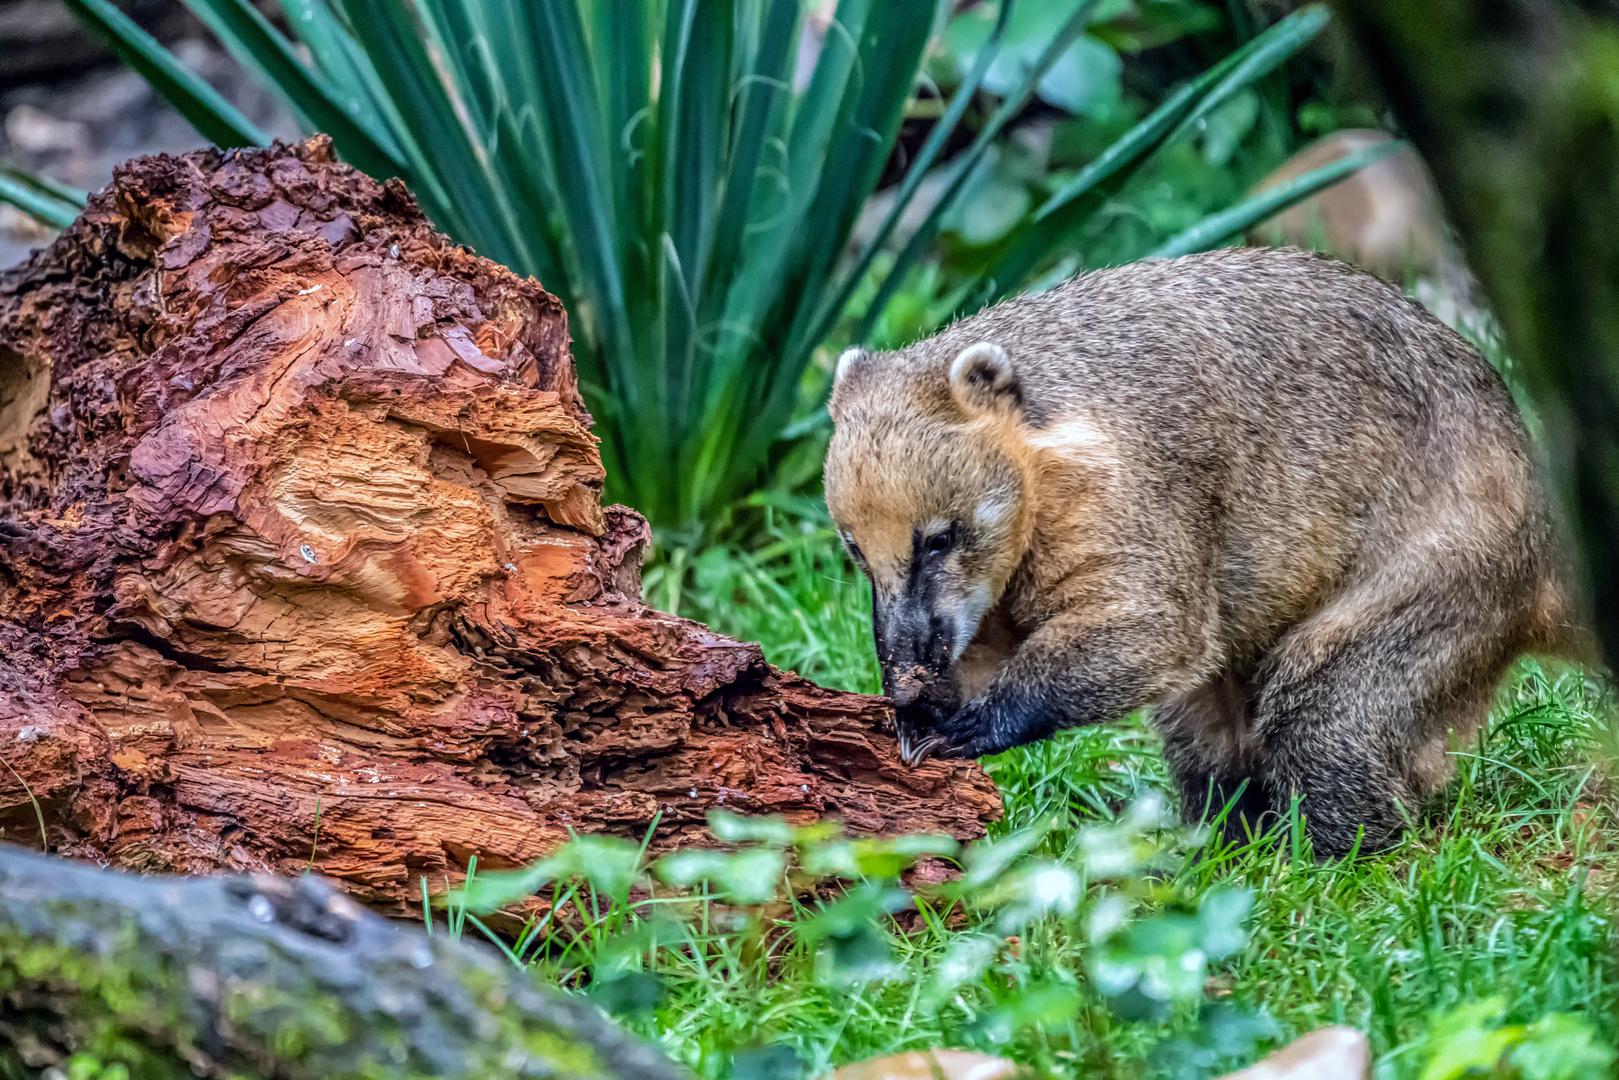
[0,845,682,1080]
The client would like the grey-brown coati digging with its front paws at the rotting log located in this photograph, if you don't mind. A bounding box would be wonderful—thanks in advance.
[826,248,1569,857]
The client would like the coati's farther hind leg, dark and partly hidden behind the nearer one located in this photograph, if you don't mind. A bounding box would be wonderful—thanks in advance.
[1153,674,1271,842]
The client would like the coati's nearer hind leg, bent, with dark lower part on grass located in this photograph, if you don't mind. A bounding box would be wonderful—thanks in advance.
[1255,580,1519,857]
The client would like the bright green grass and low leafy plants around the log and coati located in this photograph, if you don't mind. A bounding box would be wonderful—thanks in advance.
[459,515,1619,1080]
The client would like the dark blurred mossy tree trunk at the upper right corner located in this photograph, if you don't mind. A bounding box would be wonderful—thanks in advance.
[1337,0,1619,664]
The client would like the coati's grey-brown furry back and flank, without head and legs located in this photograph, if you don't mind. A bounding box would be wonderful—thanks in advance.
[905,248,1566,659]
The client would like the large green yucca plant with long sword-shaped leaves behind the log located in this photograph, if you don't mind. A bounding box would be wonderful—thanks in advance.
[9,0,1392,539]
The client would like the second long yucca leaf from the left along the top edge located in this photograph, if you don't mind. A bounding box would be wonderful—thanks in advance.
[177,0,405,180]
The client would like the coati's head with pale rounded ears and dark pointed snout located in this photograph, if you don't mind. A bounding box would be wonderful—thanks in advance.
[826,343,1031,761]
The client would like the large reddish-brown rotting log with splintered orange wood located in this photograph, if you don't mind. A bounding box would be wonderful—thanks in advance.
[0,139,999,912]
